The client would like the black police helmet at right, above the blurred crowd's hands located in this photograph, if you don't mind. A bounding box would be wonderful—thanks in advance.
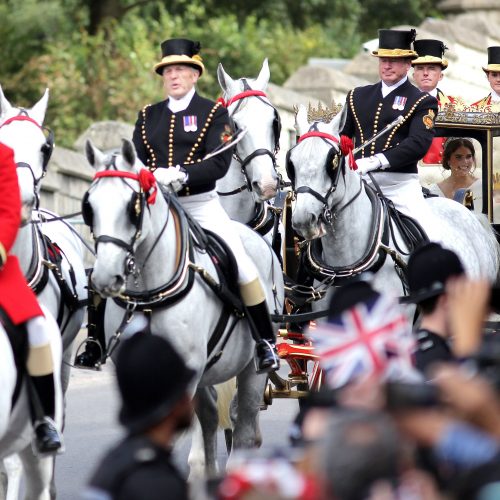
[400,243,465,304]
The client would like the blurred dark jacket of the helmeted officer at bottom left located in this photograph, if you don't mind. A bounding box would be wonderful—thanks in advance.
[82,436,188,500]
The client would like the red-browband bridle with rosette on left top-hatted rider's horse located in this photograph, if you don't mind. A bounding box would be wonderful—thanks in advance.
[82,154,158,277]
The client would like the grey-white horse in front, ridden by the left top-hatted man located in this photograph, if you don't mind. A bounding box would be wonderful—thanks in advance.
[83,141,283,473]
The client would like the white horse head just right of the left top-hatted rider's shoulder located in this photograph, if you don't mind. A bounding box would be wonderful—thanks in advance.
[217,59,281,201]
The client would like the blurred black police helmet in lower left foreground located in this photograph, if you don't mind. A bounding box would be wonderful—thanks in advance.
[116,332,195,434]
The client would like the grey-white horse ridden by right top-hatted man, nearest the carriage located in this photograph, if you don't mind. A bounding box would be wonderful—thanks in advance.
[287,106,499,302]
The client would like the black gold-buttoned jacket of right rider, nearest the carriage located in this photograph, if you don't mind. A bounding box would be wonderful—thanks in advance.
[341,80,438,173]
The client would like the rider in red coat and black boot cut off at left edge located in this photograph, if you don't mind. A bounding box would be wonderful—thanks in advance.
[0,143,63,454]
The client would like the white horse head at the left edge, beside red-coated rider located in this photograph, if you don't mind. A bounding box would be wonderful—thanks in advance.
[0,87,54,218]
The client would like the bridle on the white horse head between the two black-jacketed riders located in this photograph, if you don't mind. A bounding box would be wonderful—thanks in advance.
[218,78,281,196]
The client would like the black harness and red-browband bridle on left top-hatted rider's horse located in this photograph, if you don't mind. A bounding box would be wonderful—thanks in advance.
[82,163,254,370]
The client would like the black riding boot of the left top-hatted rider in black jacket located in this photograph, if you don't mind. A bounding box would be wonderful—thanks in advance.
[246,301,280,373]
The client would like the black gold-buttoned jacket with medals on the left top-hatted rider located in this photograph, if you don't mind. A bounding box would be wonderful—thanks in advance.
[133,93,232,196]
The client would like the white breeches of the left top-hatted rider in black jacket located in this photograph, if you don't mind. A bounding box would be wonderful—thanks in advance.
[179,191,258,284]
